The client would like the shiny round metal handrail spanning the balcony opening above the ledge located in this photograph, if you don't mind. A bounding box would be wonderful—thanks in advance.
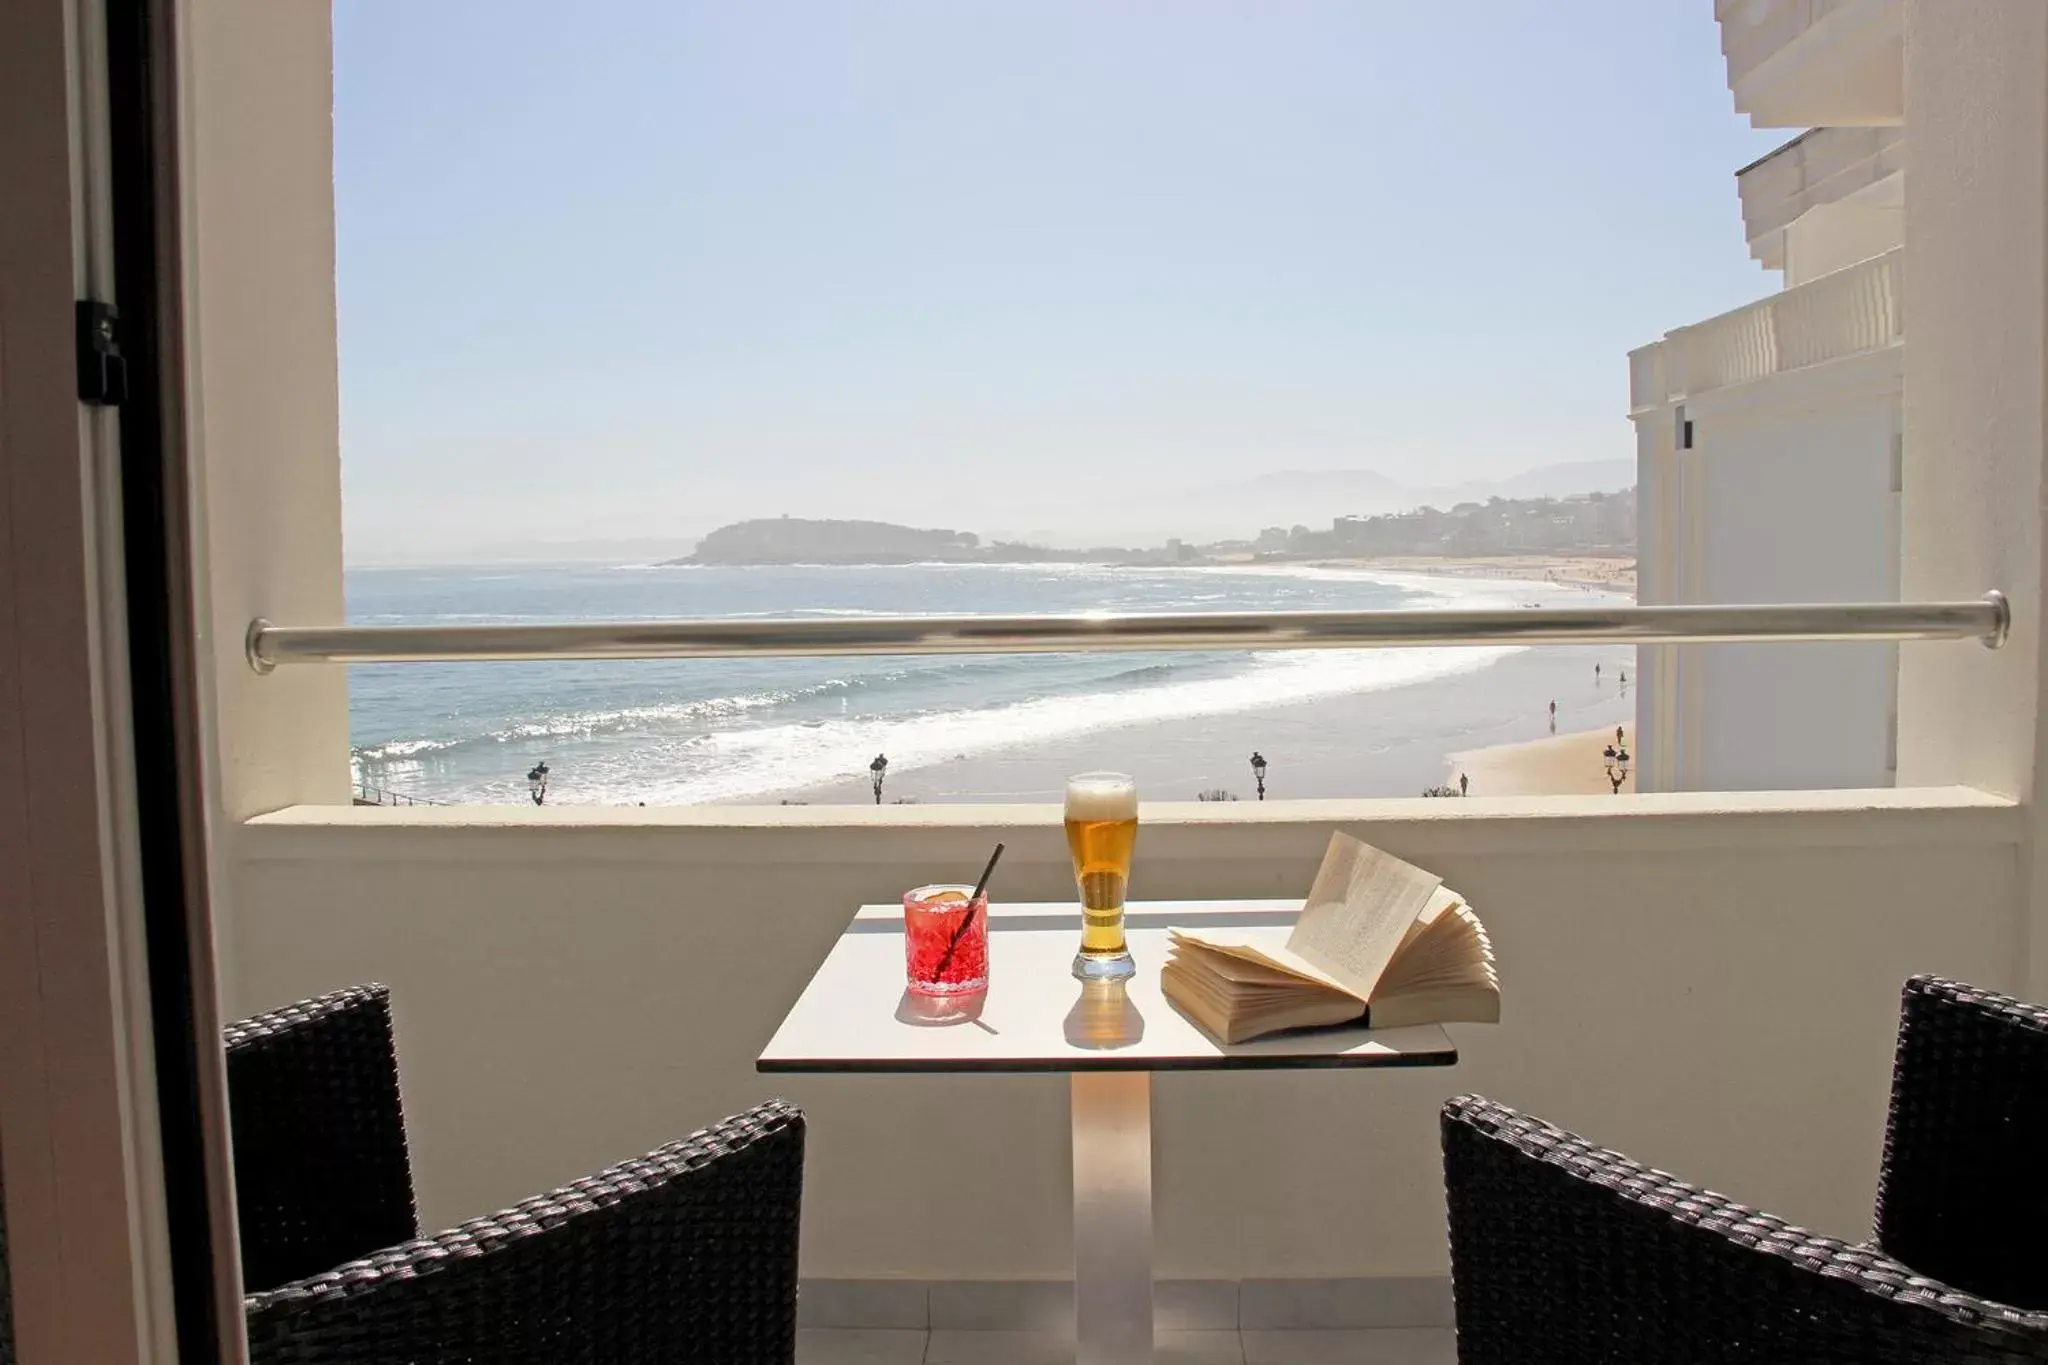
[248,591,2011,673]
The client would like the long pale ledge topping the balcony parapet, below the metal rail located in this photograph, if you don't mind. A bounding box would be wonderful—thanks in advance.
[243,786,2023,864]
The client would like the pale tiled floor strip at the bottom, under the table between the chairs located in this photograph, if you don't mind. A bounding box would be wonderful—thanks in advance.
[797,1328,1458,1365]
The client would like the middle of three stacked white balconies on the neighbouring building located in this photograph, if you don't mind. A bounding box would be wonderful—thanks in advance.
[1735,127,1907,284]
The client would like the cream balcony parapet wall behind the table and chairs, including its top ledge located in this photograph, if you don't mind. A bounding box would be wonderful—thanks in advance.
[225,790,2021,1279]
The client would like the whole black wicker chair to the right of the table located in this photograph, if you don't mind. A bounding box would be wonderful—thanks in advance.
[1444,976,2048,1365]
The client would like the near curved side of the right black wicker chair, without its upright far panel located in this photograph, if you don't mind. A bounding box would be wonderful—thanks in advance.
[1444,1095,2048,1365]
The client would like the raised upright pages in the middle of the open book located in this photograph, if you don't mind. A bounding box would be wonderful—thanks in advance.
[1286,831,1444,1001]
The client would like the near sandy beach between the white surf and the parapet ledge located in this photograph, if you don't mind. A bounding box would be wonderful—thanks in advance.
[774,645,1636,804]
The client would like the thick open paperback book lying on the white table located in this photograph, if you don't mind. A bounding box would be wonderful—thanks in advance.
[1159,833,1501,1044]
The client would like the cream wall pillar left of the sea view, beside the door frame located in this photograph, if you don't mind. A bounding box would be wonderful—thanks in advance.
[186,0,348,822]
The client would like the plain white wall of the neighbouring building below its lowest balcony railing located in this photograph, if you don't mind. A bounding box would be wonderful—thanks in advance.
[1636,346,1905,792]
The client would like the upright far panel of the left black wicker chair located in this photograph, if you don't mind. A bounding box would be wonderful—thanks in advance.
[223,986,420,1291]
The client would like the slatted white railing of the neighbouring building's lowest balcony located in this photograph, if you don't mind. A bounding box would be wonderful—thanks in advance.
[1628,250,1905,411]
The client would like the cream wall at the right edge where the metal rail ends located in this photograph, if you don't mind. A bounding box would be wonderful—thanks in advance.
[1898,0,2048,995]
